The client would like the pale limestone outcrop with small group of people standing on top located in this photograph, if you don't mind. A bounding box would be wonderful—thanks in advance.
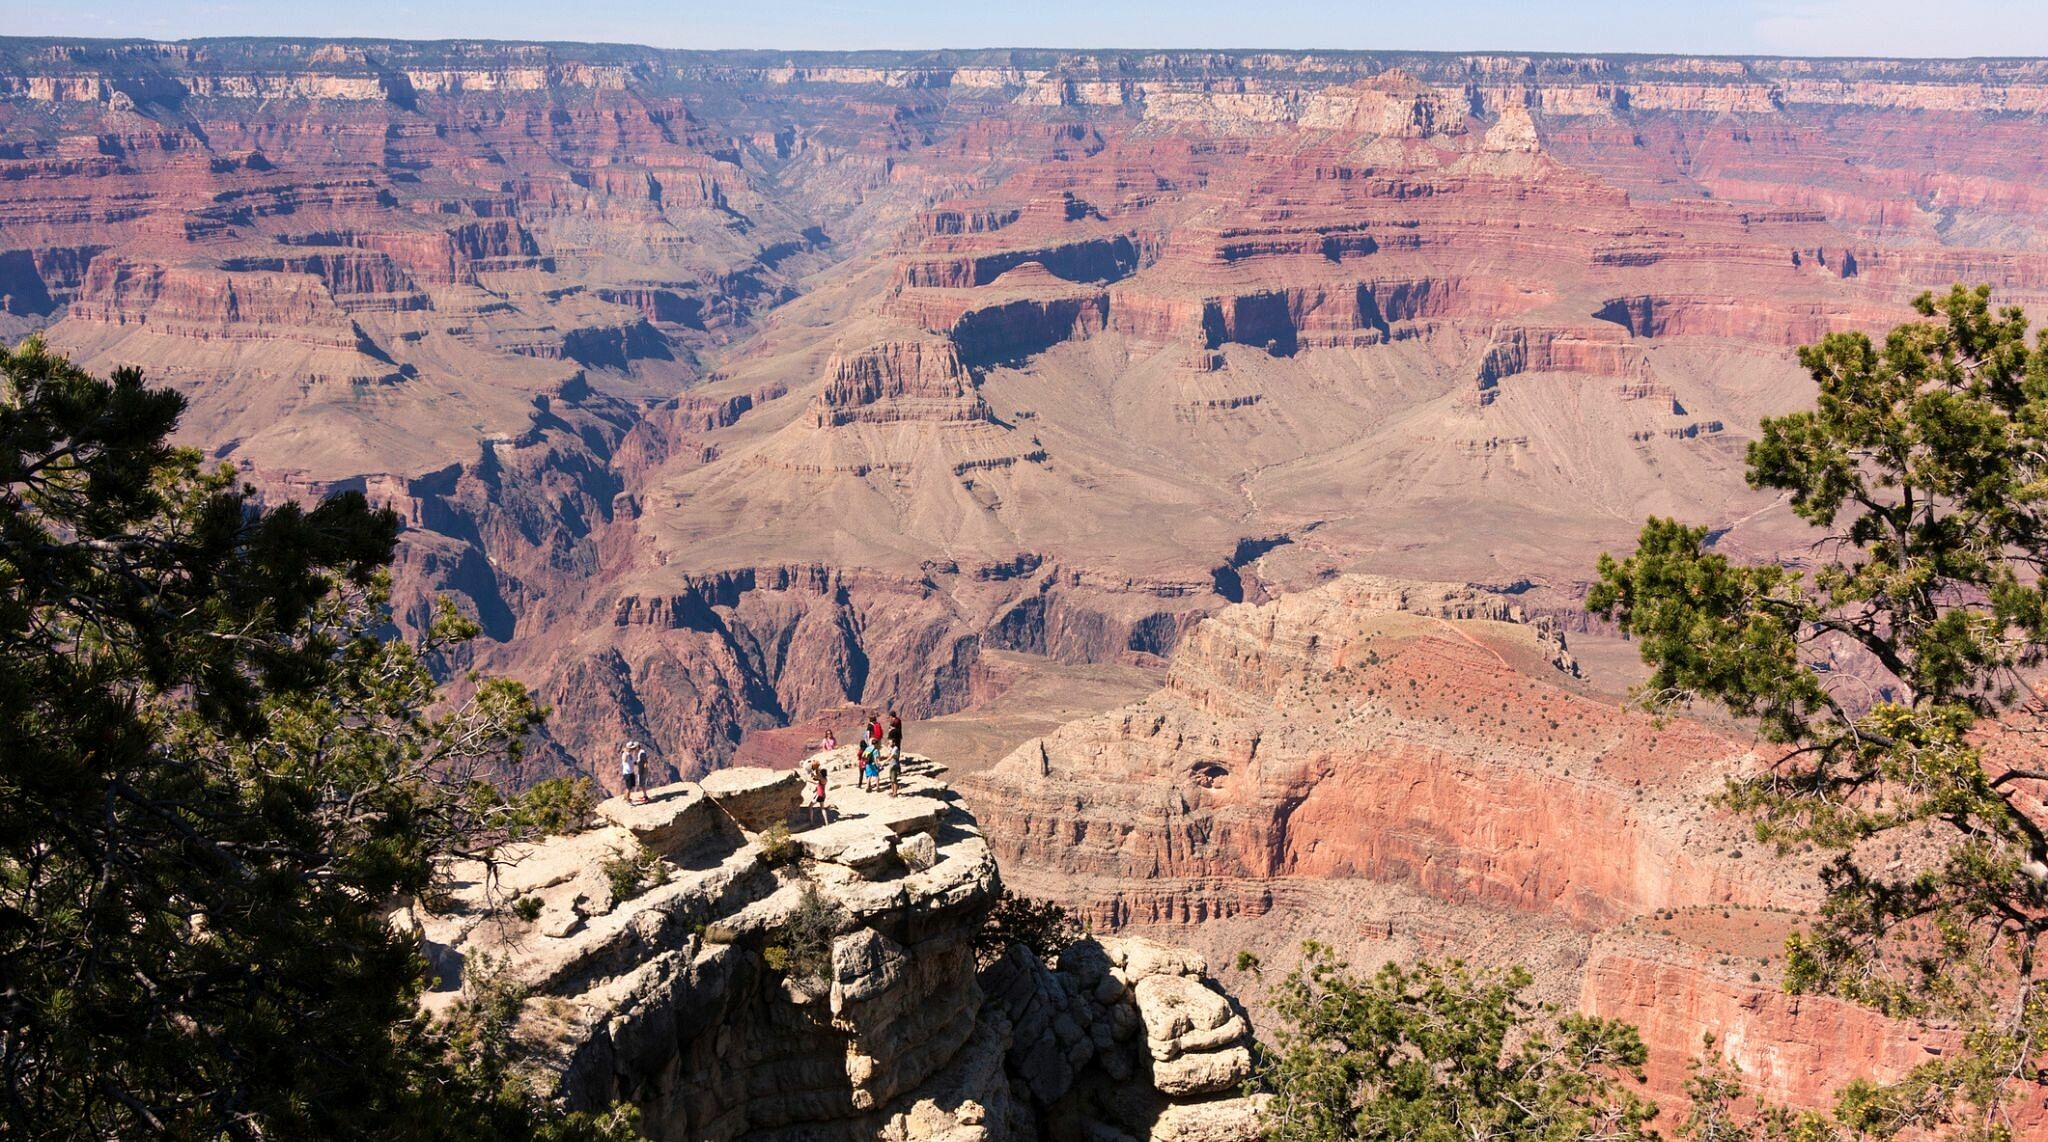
[420,749,1257,1142]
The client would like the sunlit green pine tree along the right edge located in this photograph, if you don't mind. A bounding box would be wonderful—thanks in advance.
[1587,287,2048,1136]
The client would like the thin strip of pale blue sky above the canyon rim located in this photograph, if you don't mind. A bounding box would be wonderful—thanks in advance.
[12,0,2048,55]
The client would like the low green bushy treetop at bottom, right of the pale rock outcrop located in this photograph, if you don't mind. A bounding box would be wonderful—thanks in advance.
[1260,941,1657,1142]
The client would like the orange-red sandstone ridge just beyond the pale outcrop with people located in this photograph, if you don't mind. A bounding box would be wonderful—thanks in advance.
[963,577,1990,1126]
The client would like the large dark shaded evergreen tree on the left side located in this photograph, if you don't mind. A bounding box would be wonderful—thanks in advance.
[0,340,630,1138]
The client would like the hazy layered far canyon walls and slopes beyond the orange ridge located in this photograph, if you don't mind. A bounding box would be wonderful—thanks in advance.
[0,39,2048,776]
